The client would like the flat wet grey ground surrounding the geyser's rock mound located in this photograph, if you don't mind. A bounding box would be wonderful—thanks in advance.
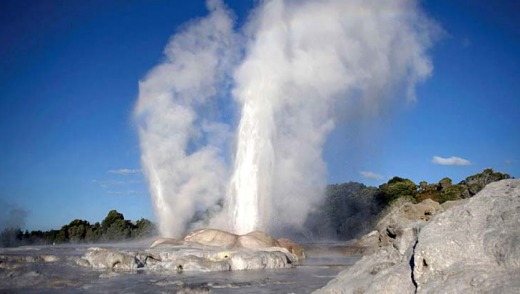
[0,244,360,293]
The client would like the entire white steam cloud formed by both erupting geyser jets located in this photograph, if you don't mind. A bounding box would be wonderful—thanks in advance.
[135,0,436,236]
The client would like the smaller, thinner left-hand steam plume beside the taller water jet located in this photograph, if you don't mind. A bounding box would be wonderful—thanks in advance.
[135,1,238,236]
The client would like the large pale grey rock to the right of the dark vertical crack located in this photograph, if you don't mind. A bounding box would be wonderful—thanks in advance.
[413,180,520,293]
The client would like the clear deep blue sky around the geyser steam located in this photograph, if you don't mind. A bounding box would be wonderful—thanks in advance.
[0,0,520,230]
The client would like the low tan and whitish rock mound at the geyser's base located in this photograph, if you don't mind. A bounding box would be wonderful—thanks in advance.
[77,229,305,271]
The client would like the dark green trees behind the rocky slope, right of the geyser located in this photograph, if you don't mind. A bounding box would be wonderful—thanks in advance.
[304,168,510,240]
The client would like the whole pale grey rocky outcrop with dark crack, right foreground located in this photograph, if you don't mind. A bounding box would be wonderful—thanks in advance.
[316,180,520,293]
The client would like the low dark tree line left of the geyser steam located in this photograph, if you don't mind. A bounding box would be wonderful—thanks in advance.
[0,210,157,247]
